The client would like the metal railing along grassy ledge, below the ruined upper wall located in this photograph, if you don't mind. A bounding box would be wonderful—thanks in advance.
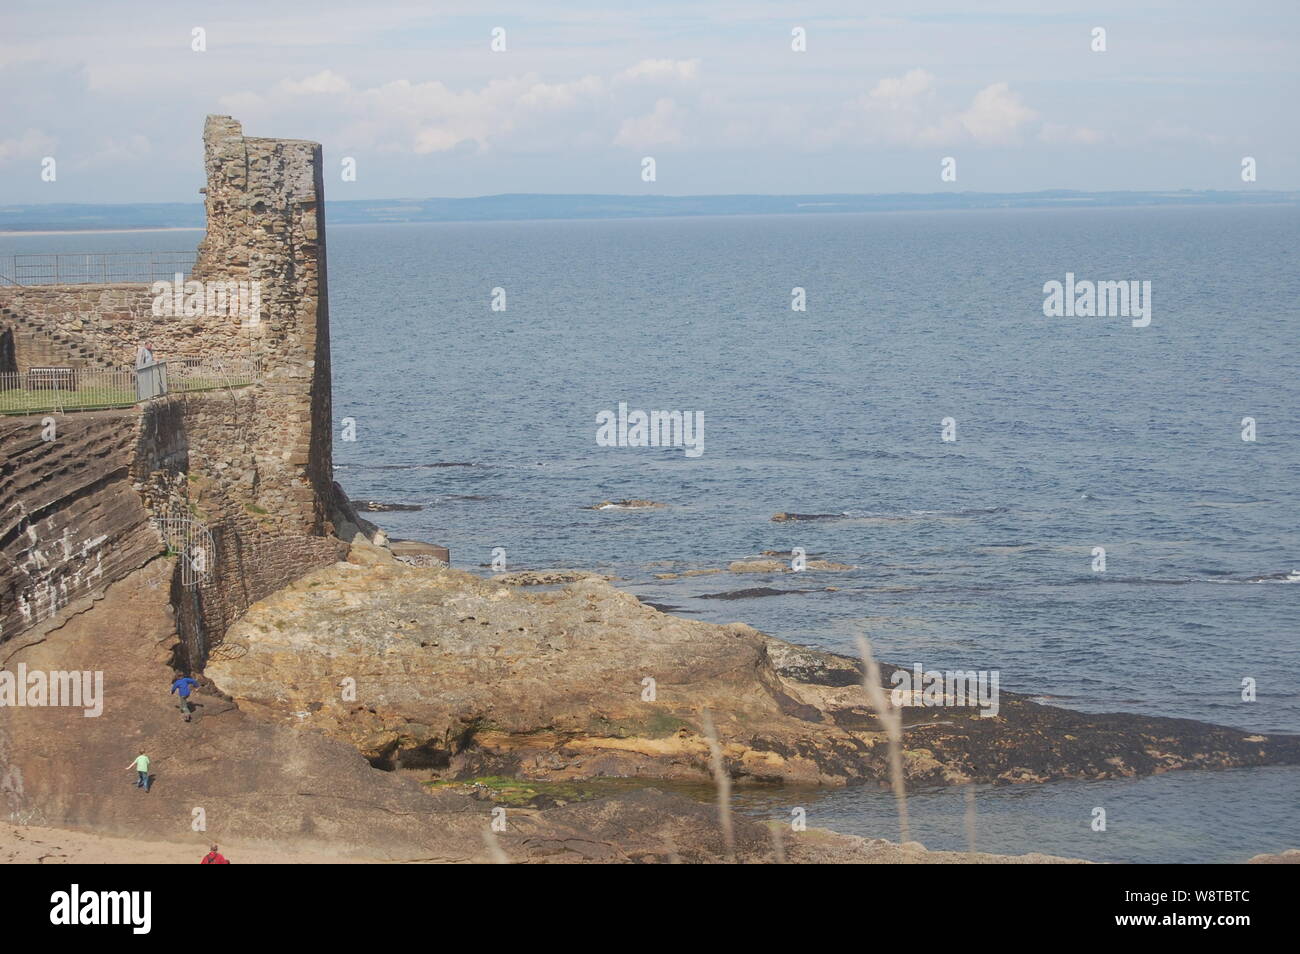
[0,357,260,415]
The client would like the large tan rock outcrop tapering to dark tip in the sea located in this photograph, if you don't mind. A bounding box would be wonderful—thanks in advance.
[208,563,1300,785]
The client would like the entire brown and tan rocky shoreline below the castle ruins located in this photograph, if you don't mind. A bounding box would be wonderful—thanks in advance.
[0,514,1300,864]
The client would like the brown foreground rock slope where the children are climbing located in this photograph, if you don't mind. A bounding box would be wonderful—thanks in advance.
[0,559,1086,863]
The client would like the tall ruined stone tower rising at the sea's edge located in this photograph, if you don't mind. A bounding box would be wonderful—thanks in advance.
[192,116,333,534]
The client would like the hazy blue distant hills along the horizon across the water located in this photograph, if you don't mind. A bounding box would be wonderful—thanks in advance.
[0,190,1300,231]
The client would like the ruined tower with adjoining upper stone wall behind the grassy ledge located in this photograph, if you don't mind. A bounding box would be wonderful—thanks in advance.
[0,116,333,534]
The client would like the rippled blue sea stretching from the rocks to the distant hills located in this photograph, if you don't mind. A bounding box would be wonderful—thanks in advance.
[0,207,1300,862]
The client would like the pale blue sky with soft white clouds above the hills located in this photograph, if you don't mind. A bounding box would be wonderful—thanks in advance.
[0,0,1300,204]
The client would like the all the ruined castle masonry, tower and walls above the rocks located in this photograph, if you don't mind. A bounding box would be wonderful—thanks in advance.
[0,116,347,668]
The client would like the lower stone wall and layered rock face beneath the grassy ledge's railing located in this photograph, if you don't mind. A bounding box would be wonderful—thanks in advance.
[0,389,347,669]
